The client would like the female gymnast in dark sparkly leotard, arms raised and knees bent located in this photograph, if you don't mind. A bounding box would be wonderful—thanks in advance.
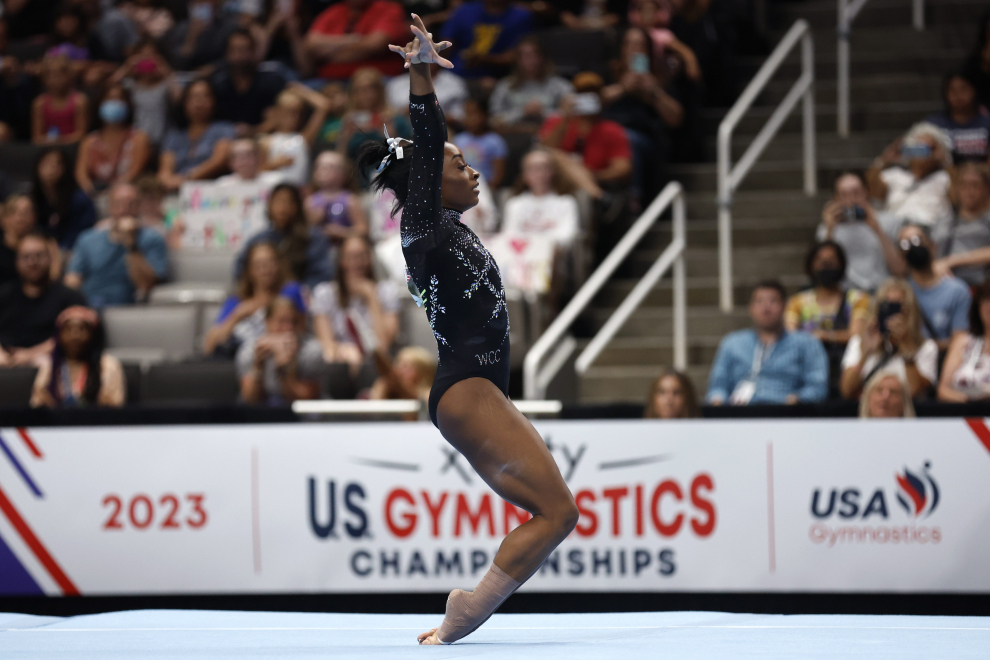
[359,14,578,644]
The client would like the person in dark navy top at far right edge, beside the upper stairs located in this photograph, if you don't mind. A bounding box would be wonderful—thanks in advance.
[925,73,990,165]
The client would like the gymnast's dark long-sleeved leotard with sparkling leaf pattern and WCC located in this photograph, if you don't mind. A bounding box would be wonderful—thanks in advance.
[400,94,509,425]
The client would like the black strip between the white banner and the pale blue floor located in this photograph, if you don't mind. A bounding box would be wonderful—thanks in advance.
[0,592,990,616]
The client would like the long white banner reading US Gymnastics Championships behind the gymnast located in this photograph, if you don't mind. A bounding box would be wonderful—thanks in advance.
[0,419,990,595]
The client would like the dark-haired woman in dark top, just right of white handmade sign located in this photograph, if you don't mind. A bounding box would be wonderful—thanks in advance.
[234,183,333,290]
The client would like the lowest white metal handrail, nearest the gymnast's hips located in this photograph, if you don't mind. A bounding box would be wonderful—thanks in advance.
[523,181,687,399]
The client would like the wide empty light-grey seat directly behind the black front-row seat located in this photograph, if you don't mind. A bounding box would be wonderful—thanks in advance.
[103,305,197,360]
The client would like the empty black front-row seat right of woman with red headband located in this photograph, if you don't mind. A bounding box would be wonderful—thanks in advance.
[143,362,240,404]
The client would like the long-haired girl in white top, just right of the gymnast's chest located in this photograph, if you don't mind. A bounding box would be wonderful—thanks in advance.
[502,149,580,248]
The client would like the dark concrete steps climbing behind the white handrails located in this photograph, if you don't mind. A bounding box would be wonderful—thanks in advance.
[578,0,990,403]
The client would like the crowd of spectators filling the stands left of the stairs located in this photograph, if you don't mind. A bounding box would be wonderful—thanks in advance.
[0,0,745,406]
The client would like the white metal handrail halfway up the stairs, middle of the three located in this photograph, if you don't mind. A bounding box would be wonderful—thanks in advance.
[718,19,818,312]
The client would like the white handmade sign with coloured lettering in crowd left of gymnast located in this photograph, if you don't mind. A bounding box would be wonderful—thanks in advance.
[179,181,271,249]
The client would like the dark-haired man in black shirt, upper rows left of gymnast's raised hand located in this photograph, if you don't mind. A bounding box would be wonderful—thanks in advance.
[210,28,285,129]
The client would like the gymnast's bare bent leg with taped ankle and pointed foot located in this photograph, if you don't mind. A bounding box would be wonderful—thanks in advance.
[419,378,578,644]
